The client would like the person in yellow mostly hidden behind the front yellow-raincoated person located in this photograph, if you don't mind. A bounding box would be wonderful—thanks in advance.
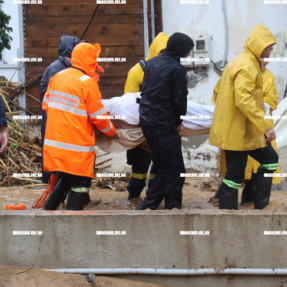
[240,61,280,205]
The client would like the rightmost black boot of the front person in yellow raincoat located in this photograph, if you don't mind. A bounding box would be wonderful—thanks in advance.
[254,168,273,209]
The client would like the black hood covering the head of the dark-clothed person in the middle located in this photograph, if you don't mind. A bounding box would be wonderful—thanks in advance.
[164,33,194,59]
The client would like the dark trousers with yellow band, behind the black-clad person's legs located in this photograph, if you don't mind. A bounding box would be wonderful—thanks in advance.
[127,147,154,198]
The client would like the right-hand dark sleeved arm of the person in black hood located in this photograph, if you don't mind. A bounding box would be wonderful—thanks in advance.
[173,68,188,126]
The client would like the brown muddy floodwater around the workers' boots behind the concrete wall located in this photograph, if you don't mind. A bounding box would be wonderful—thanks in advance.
[0,179,287,212]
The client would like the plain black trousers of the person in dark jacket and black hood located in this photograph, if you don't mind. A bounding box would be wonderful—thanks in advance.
[140,126,185,209]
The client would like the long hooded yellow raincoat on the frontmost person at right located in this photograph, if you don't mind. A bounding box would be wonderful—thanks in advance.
[209,25,276,151]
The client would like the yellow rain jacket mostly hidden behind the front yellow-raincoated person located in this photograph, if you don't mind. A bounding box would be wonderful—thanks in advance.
[245,69,280,184]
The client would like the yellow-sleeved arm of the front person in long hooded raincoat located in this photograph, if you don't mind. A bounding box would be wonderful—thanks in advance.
[234,70,272,137]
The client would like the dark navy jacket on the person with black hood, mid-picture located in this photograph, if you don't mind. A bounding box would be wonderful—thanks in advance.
[139,51,188,127]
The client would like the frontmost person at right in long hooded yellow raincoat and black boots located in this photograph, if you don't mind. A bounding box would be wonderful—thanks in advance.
[209,25,278,209]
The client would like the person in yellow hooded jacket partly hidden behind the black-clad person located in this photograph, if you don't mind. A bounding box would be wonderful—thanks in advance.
[125,32,168,200]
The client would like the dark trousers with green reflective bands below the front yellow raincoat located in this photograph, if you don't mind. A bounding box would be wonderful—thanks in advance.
[219,143,278,209]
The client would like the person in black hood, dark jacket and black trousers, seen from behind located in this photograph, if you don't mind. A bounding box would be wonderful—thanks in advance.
[136,33,194,210]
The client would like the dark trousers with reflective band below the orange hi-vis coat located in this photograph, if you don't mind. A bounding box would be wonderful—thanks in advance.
[44,172,92,210]
